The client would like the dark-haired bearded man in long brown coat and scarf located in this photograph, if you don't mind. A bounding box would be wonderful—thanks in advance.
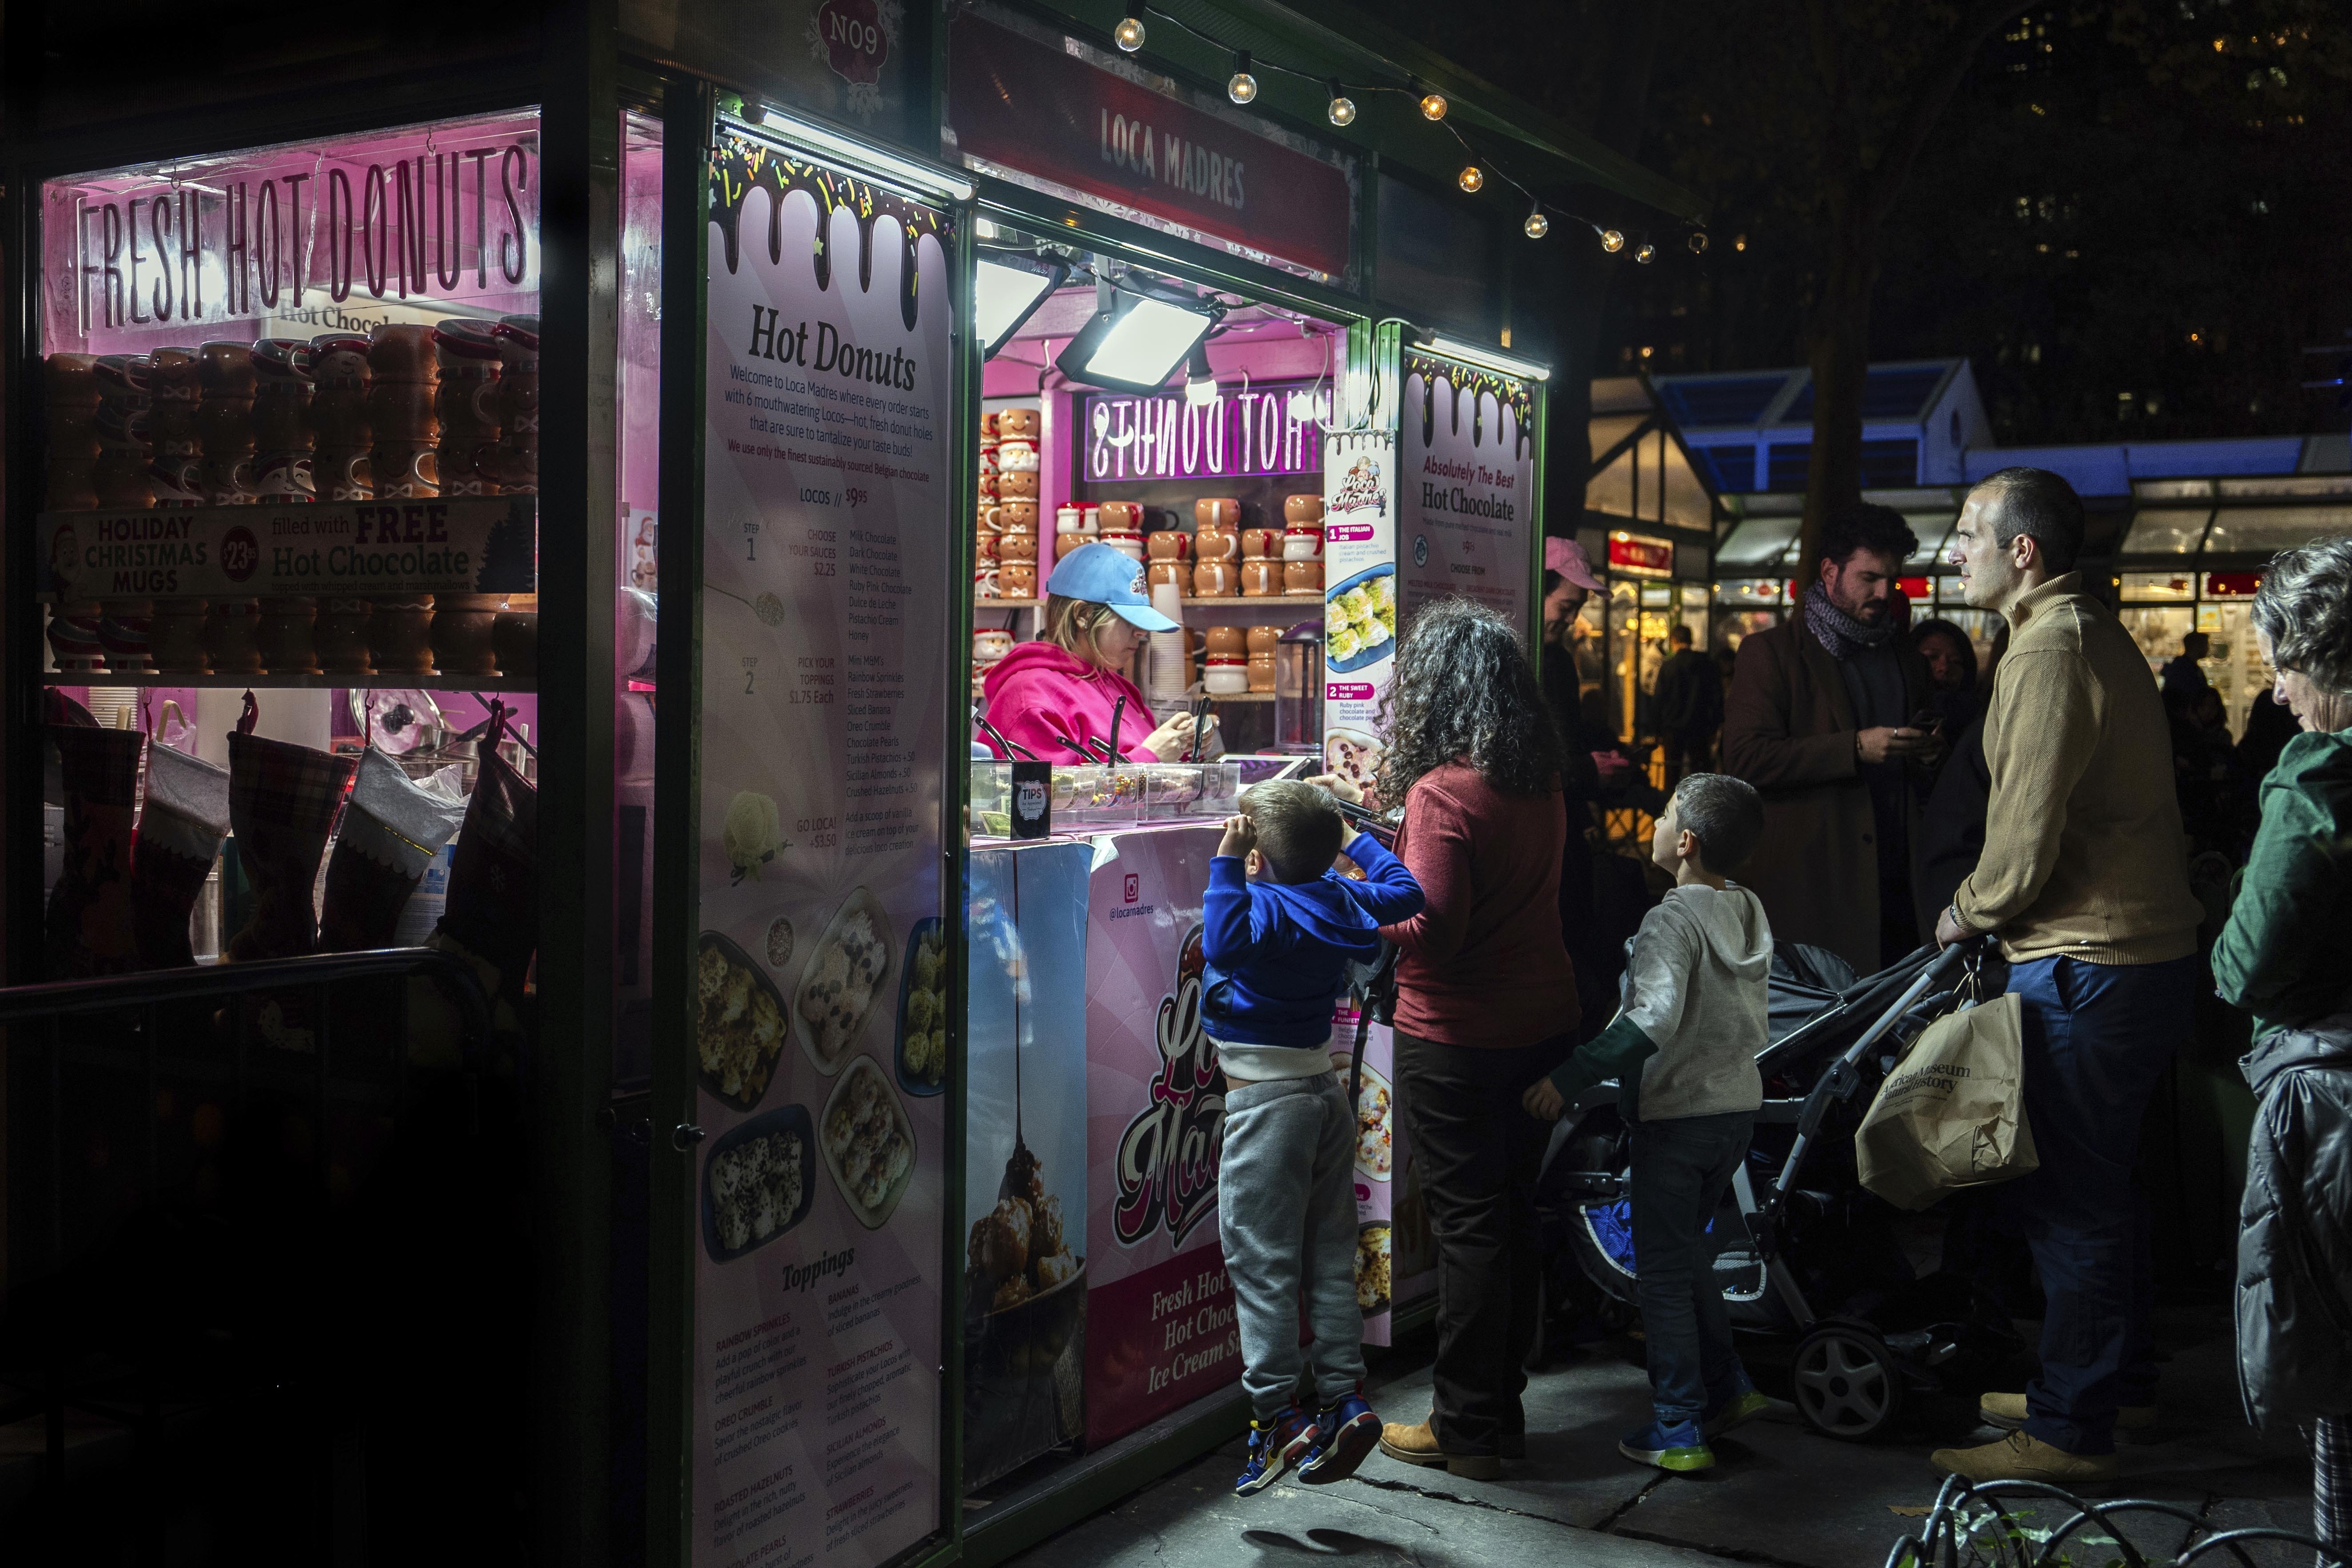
[1724,503,1940,973]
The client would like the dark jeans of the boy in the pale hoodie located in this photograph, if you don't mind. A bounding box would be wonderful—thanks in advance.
[1632,1110,1757,1427]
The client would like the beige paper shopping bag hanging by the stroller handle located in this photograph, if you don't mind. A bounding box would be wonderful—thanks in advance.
[1853,995,2042,1208]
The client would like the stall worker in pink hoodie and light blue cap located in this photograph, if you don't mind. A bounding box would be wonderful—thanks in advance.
[983,543,1214,766]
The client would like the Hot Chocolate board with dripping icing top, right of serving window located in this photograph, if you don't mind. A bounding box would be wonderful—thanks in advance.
[1397,355,1536,628]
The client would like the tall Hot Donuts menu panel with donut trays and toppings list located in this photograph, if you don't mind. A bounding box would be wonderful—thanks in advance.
[692,127,962,1568]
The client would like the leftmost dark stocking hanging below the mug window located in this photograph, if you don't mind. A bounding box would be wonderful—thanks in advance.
[47,724,146,980]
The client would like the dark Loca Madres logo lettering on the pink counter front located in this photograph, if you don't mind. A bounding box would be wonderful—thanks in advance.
[1110,924,1226,1246]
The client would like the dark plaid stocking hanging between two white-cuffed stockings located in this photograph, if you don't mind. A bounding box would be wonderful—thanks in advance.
[221,698,355,962]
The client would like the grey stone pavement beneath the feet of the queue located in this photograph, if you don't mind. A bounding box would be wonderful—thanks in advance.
[1014,1305,2310,1568]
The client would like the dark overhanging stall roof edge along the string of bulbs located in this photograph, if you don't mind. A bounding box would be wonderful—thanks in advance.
[1044,0,1703,223]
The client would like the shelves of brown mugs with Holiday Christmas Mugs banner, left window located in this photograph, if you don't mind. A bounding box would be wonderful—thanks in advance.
[38,329,539,684]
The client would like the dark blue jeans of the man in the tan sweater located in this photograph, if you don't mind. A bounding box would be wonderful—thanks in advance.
[2002,955,2197,1453]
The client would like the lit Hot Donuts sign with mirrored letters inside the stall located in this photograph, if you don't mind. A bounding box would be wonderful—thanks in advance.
[1077,381,1331,482]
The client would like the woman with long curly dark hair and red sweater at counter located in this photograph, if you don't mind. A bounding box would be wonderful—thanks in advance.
[1326,600,1576,1479]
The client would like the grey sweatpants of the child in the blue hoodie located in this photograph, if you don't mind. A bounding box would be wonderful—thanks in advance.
[1216,1072,1364,1420]
